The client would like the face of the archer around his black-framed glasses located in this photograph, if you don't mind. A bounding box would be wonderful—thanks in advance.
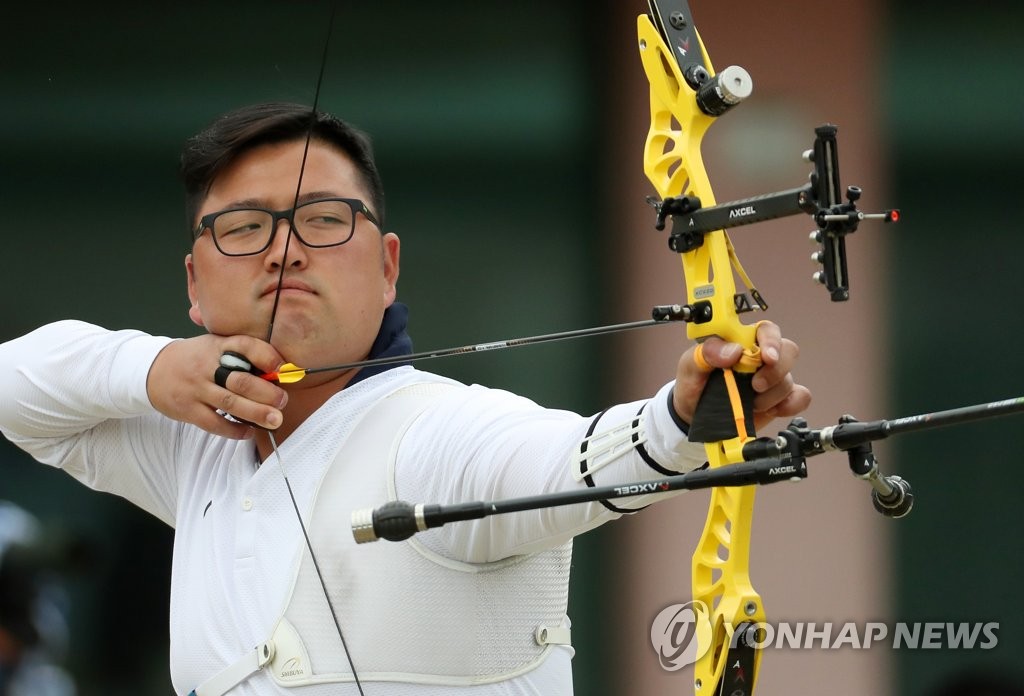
[185,140,398,366]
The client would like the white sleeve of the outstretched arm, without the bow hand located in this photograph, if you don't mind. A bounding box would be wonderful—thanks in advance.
[395,378,703,563]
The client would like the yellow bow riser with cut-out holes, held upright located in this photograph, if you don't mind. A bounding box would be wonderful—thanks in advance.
[637,2,766,694]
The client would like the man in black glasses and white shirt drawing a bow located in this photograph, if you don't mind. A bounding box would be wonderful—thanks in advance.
[0,104,810,696]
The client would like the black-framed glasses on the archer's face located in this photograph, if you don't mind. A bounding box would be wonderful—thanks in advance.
[193,199,380,256]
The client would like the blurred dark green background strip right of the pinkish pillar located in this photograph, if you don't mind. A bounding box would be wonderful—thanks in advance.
[876,2,1024,694]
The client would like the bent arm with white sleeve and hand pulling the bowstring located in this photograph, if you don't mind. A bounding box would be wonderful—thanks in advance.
[0,321,287,526]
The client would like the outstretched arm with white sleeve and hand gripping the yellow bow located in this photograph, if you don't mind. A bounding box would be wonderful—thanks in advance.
[396,324,810,562]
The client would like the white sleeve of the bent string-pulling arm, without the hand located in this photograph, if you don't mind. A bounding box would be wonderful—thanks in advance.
[0,321,180,524]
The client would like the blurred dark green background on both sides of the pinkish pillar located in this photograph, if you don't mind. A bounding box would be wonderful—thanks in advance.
[0,0,1024,696]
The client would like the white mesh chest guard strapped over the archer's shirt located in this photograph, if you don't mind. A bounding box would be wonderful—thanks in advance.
[259,383,571,687]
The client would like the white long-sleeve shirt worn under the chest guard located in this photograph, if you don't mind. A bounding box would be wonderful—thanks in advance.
[0,321,703,696]
